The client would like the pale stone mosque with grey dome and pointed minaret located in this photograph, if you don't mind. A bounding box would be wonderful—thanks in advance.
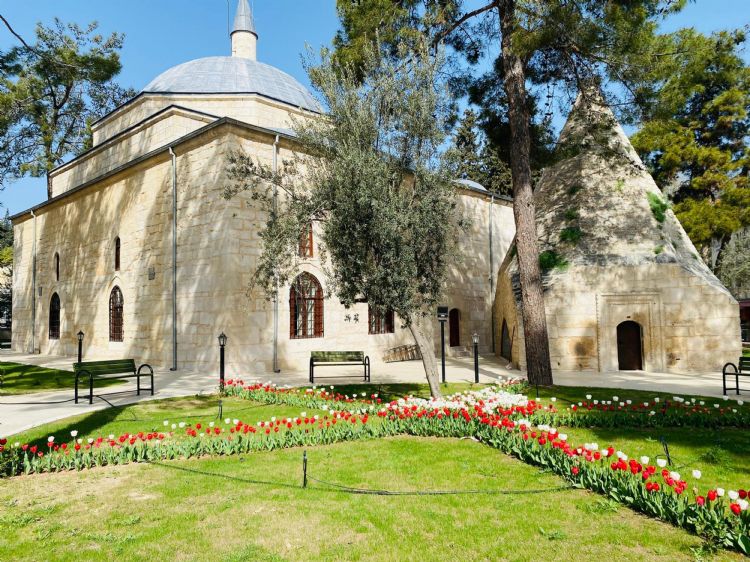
[12,0,514,376]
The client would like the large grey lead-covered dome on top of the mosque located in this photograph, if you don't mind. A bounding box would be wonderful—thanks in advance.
[143,57,321,112]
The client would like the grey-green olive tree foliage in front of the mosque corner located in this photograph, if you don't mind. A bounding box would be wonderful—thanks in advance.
[225,44,463,332]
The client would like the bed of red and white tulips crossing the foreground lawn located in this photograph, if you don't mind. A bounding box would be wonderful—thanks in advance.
[5,382,750,553]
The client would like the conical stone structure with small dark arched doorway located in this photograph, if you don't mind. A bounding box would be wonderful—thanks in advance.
[495,94,741,372]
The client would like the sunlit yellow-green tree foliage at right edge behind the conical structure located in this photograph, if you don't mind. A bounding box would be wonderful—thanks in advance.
[632,29,750,260]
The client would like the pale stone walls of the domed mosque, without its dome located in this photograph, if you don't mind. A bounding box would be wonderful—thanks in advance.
[13,114,513,375]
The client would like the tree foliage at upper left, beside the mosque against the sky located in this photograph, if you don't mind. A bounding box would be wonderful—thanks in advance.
[0,19,135,186]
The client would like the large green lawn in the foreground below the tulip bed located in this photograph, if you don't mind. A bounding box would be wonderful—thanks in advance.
[0,437,741,560]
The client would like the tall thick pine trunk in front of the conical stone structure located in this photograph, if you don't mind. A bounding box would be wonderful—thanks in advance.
[498,0,552,385]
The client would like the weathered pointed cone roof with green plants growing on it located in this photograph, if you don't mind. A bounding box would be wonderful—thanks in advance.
[501,89,726,291]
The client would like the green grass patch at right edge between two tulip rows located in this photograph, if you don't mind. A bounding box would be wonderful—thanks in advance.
[558,428,750,490]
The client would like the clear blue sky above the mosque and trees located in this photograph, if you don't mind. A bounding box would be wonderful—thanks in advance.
[0,0,750,214]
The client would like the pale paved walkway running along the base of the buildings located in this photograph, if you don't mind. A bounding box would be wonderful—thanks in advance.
[0,351,736,436]
